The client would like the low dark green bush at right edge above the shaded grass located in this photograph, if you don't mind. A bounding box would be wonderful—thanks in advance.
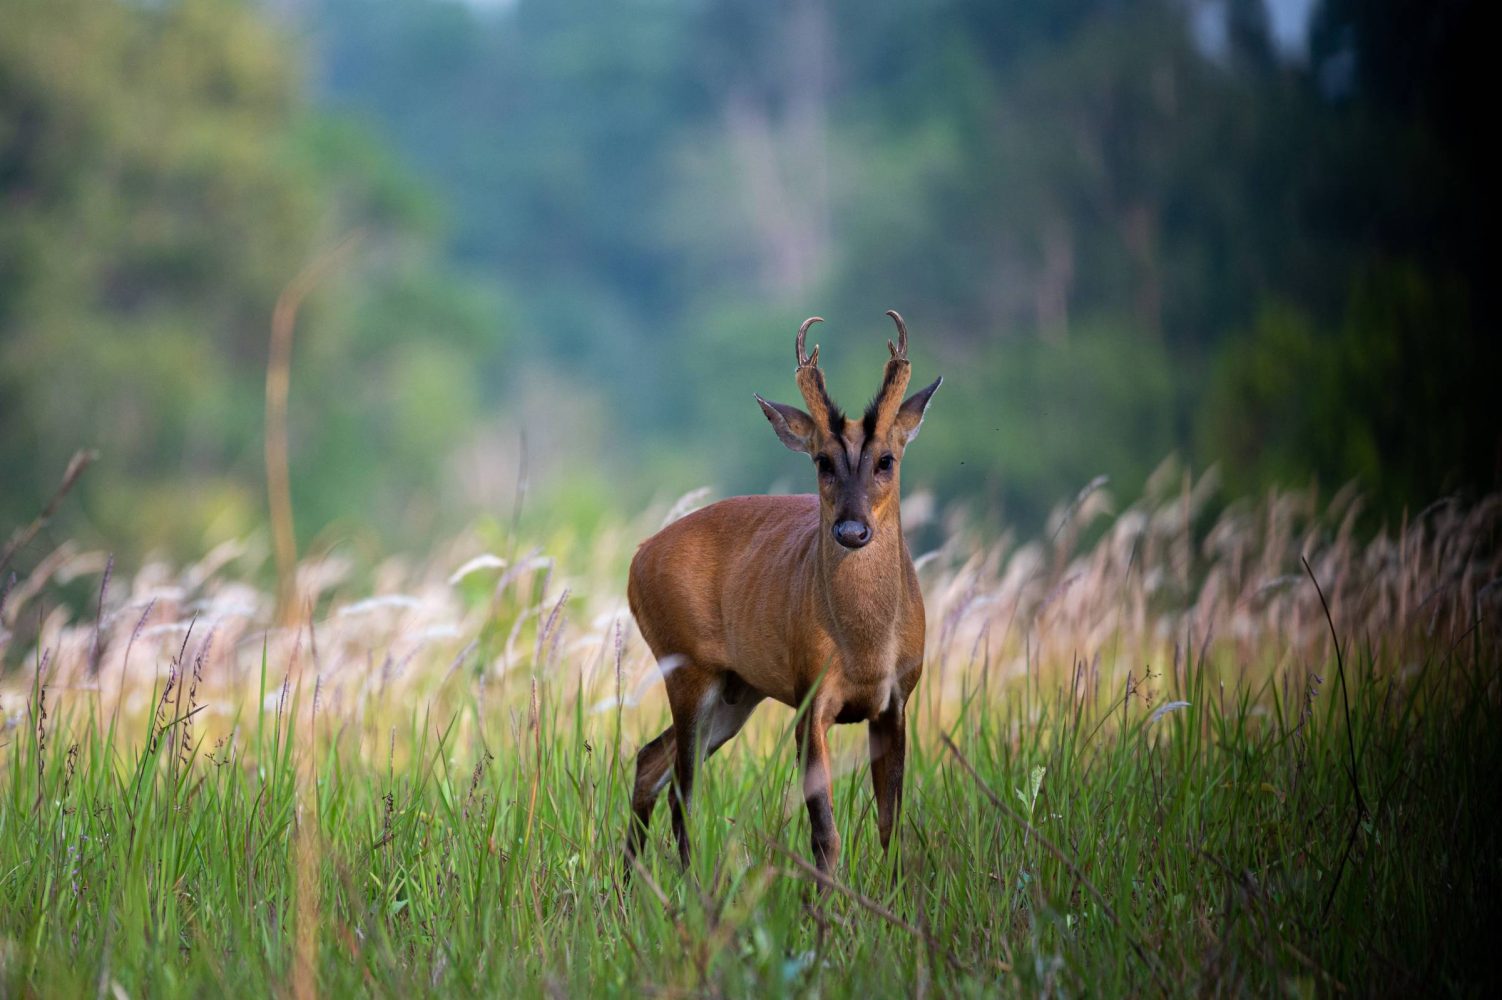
[1200,264,1502,512]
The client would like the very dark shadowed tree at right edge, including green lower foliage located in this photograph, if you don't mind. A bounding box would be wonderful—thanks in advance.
[1202,0,1502,517]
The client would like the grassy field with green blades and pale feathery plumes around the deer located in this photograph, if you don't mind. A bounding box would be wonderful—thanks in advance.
[0,473,1502,997]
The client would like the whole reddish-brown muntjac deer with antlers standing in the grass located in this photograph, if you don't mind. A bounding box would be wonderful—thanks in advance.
[626,312,943,874]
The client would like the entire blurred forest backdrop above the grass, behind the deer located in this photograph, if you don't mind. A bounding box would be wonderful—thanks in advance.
[0,0,1502,562]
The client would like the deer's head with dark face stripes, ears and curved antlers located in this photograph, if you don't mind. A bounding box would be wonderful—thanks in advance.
[756,309,943,548]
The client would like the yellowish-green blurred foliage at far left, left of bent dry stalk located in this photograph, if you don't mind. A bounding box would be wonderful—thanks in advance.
[0,0,317,541]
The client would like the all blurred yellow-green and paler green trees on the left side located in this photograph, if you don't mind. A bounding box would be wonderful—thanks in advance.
[0,0,497,561]
